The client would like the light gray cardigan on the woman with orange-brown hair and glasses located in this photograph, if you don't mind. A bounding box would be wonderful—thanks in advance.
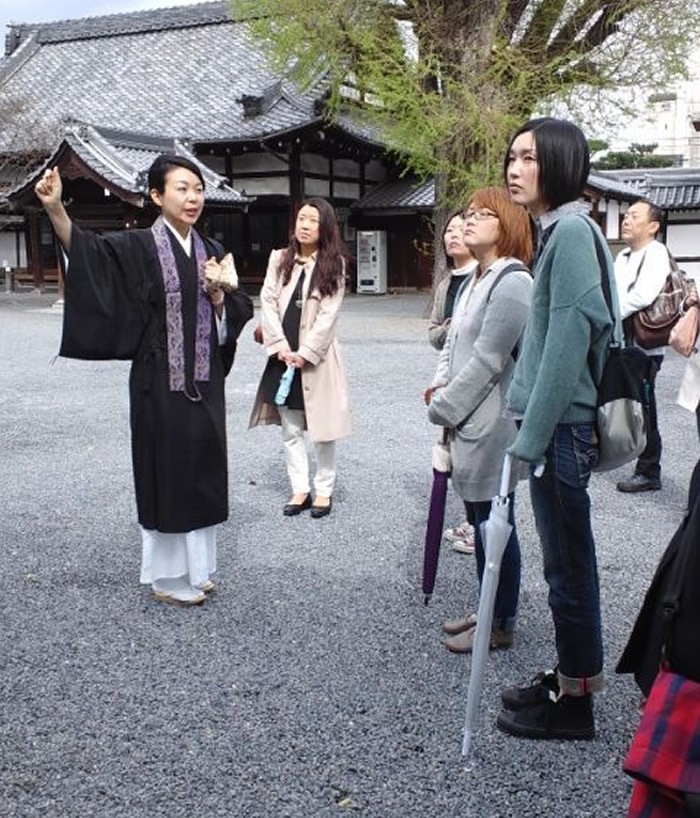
[428,258,532,502]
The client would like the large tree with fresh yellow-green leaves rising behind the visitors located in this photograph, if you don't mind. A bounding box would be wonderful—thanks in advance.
[232,0,700,274]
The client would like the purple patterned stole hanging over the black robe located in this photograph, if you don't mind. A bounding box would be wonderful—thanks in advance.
[151,216,212,401]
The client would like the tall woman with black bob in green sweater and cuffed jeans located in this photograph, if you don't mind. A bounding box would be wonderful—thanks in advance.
[498,118,617,739]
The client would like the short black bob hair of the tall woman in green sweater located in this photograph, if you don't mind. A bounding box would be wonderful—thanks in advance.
[503,117,591,210]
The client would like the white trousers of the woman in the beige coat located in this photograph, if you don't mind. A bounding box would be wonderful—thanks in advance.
[277,406,335,497]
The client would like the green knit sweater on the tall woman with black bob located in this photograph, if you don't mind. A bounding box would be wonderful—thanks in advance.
[506,215,619,463]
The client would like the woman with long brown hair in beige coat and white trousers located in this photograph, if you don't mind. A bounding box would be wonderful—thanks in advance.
[250,198,351,517]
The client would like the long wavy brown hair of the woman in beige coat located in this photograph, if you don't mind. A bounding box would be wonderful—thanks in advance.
[277,196,349,296]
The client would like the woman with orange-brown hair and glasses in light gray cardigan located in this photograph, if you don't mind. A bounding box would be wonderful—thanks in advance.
[425,187,532,653]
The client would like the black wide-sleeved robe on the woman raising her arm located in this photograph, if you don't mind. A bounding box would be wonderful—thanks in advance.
[60,226,253,533]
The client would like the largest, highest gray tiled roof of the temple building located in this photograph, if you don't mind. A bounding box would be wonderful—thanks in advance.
[0,2,380,151]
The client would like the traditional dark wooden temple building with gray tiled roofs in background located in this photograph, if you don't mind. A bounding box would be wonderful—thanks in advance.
[0,1,700,292]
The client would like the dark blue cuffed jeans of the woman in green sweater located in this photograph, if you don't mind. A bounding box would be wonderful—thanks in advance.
[530,424,603,695]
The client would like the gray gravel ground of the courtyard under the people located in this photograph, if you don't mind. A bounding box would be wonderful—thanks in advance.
[0,294,698,818]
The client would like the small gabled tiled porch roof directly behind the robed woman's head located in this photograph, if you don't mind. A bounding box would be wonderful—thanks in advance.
[7,123,253,207]
